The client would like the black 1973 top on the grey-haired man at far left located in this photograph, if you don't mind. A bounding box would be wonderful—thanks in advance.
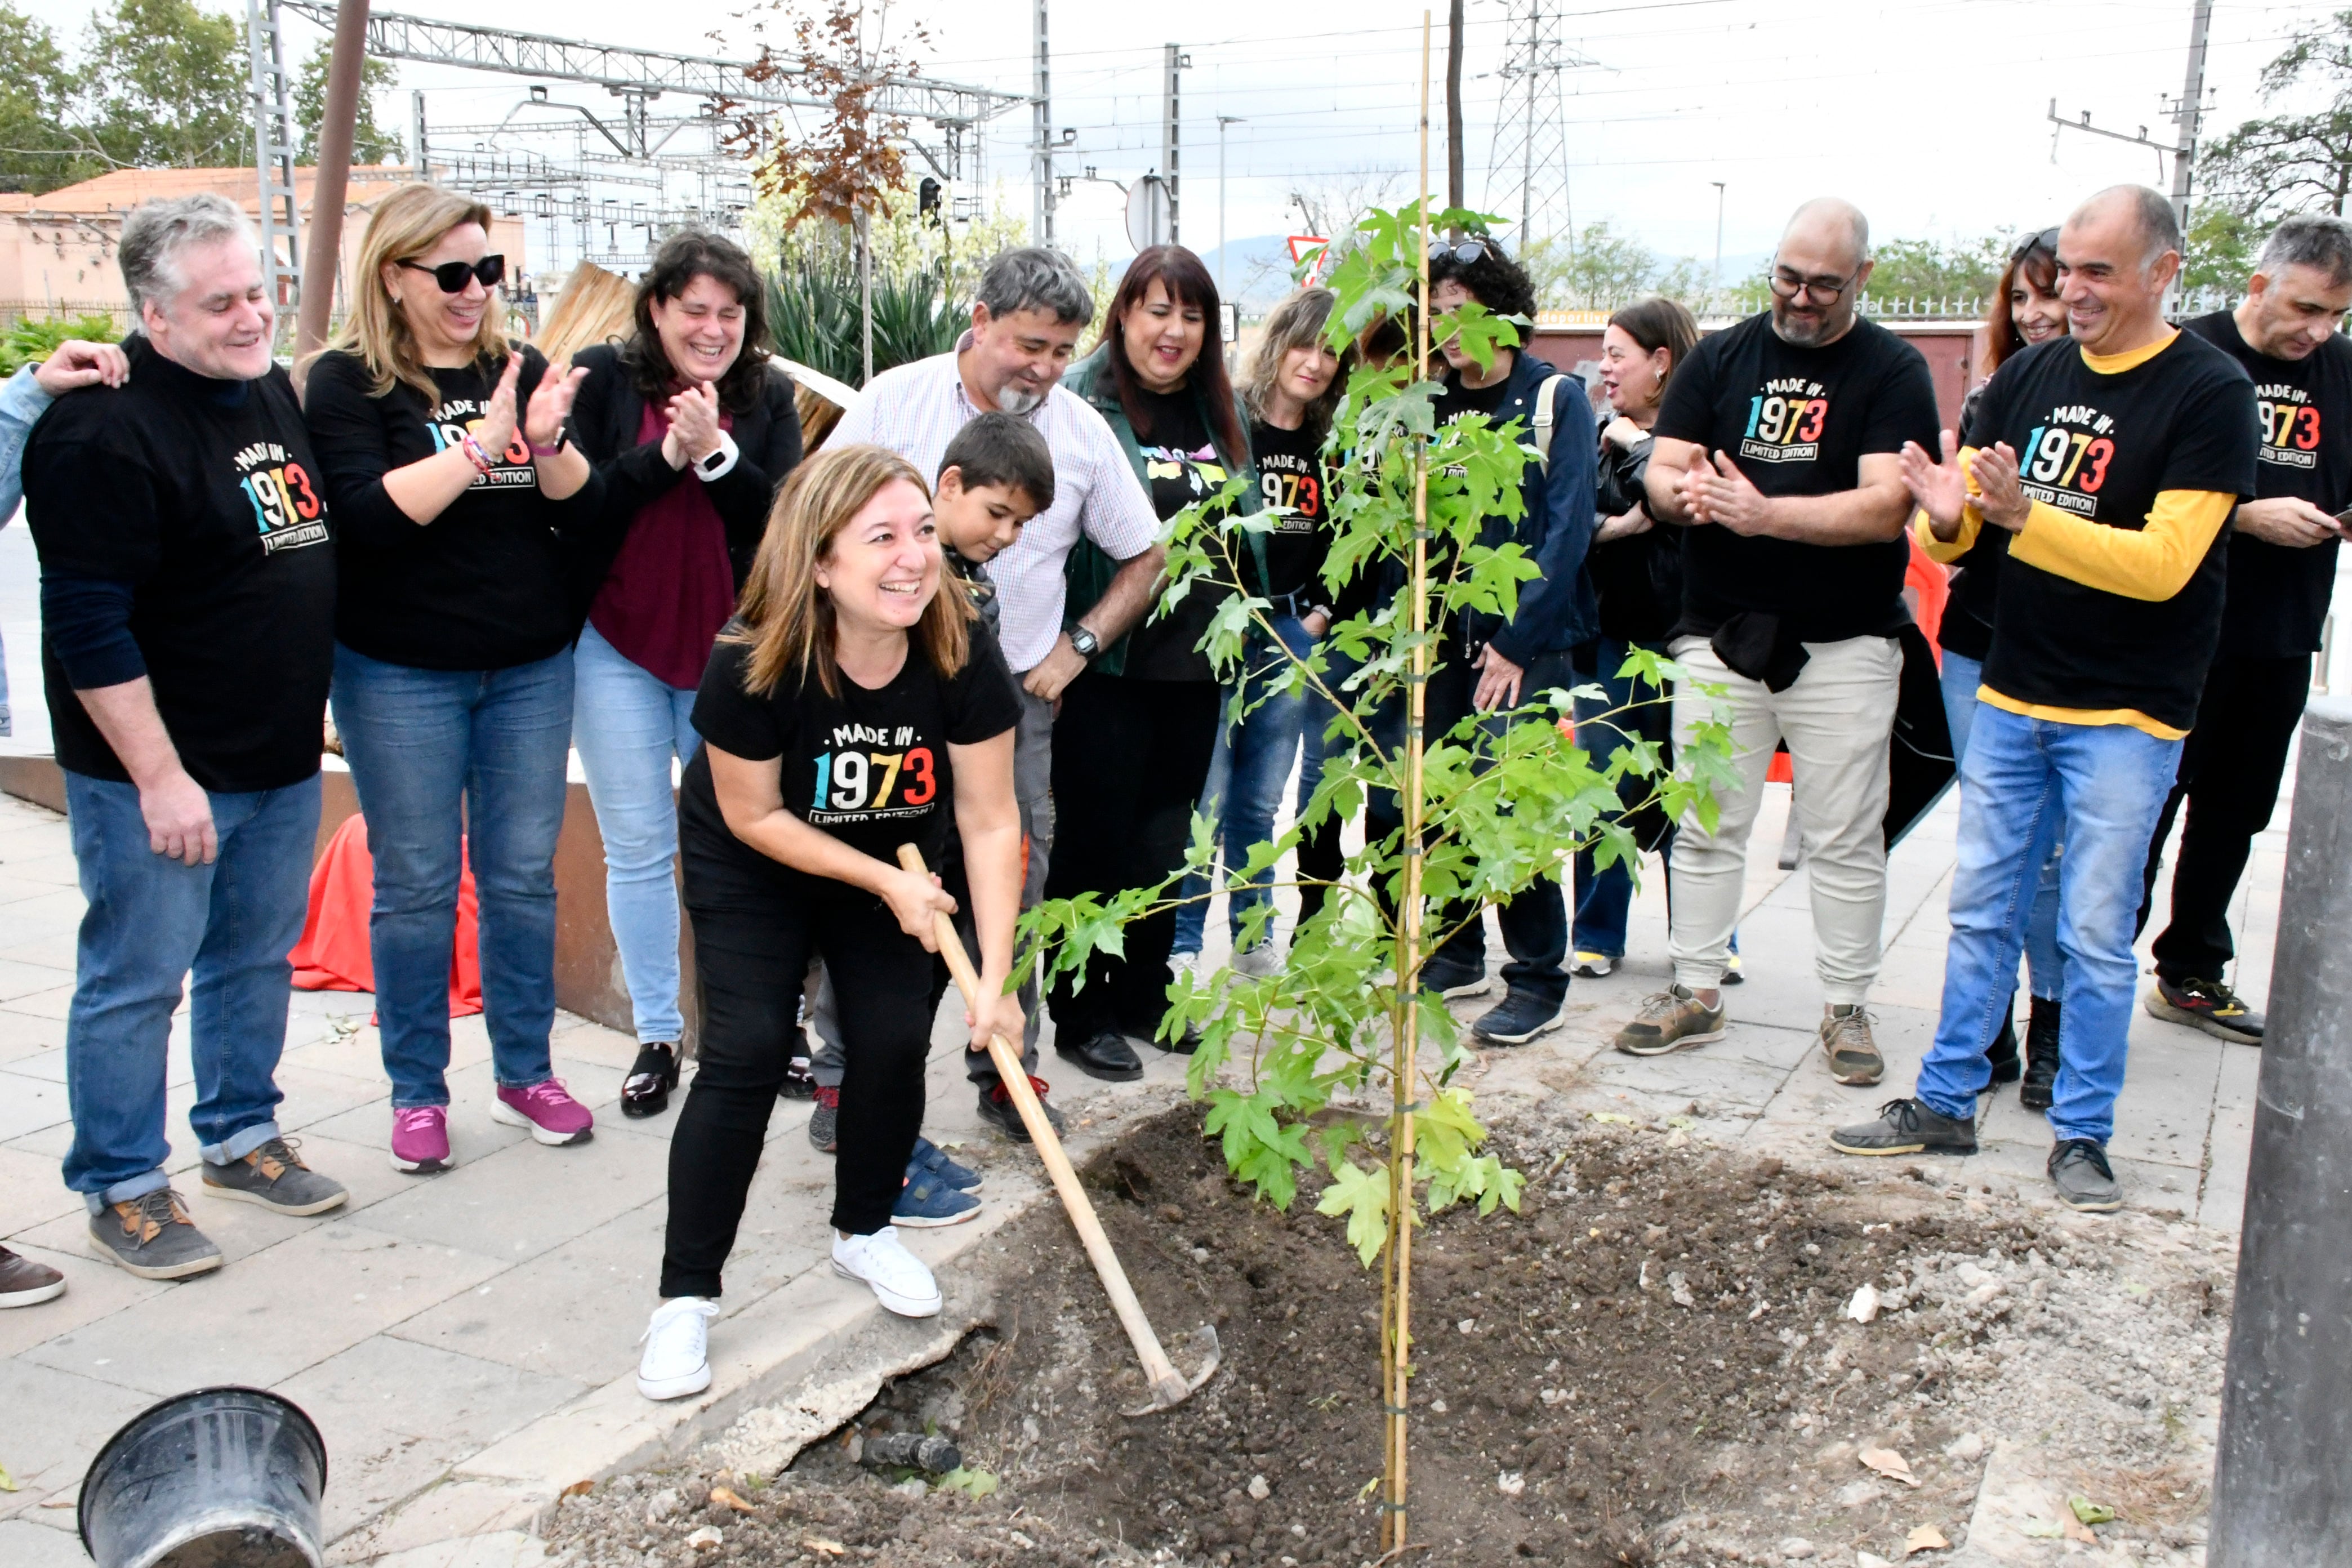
[24,336,336,792]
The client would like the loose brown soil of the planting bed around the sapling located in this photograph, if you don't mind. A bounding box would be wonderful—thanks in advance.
[548,1107,2228,1568]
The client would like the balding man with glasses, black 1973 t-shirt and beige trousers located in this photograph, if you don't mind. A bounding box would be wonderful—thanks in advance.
[1616,198,1936,1084]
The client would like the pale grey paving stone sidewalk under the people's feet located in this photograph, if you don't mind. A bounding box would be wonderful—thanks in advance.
[0,747,2286,1568]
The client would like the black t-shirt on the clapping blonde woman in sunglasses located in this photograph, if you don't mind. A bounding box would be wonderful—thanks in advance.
[304,348,595,670]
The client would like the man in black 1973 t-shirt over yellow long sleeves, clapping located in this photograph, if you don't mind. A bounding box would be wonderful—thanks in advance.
[1830,186,2258,1213]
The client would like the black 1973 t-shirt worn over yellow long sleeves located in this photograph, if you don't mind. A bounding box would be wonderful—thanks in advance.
[1962,332,2256,729]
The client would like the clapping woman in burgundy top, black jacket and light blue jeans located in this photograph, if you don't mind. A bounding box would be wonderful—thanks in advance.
[572,228,800,1117]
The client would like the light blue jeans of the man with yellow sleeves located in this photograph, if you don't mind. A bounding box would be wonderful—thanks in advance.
[1917,703,2180,1143]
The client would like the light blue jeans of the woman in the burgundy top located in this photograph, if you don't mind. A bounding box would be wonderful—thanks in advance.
[572,625,701,1046]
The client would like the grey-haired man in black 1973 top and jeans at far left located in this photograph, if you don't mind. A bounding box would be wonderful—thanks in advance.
[24,195,346,1279]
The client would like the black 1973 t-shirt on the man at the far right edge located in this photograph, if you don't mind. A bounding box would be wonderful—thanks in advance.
[2188,310,2352,658]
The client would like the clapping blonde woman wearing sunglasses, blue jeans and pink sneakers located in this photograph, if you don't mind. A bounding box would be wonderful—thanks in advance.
[304,186,600,1173]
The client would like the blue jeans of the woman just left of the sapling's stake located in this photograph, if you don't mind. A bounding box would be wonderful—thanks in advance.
[1174,616,1322,952]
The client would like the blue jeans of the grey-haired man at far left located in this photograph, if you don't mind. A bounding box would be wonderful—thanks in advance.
[66,773,318,1213]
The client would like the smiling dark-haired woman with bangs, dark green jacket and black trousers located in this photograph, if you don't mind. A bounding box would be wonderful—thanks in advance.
[1044,244,1266,1081]
